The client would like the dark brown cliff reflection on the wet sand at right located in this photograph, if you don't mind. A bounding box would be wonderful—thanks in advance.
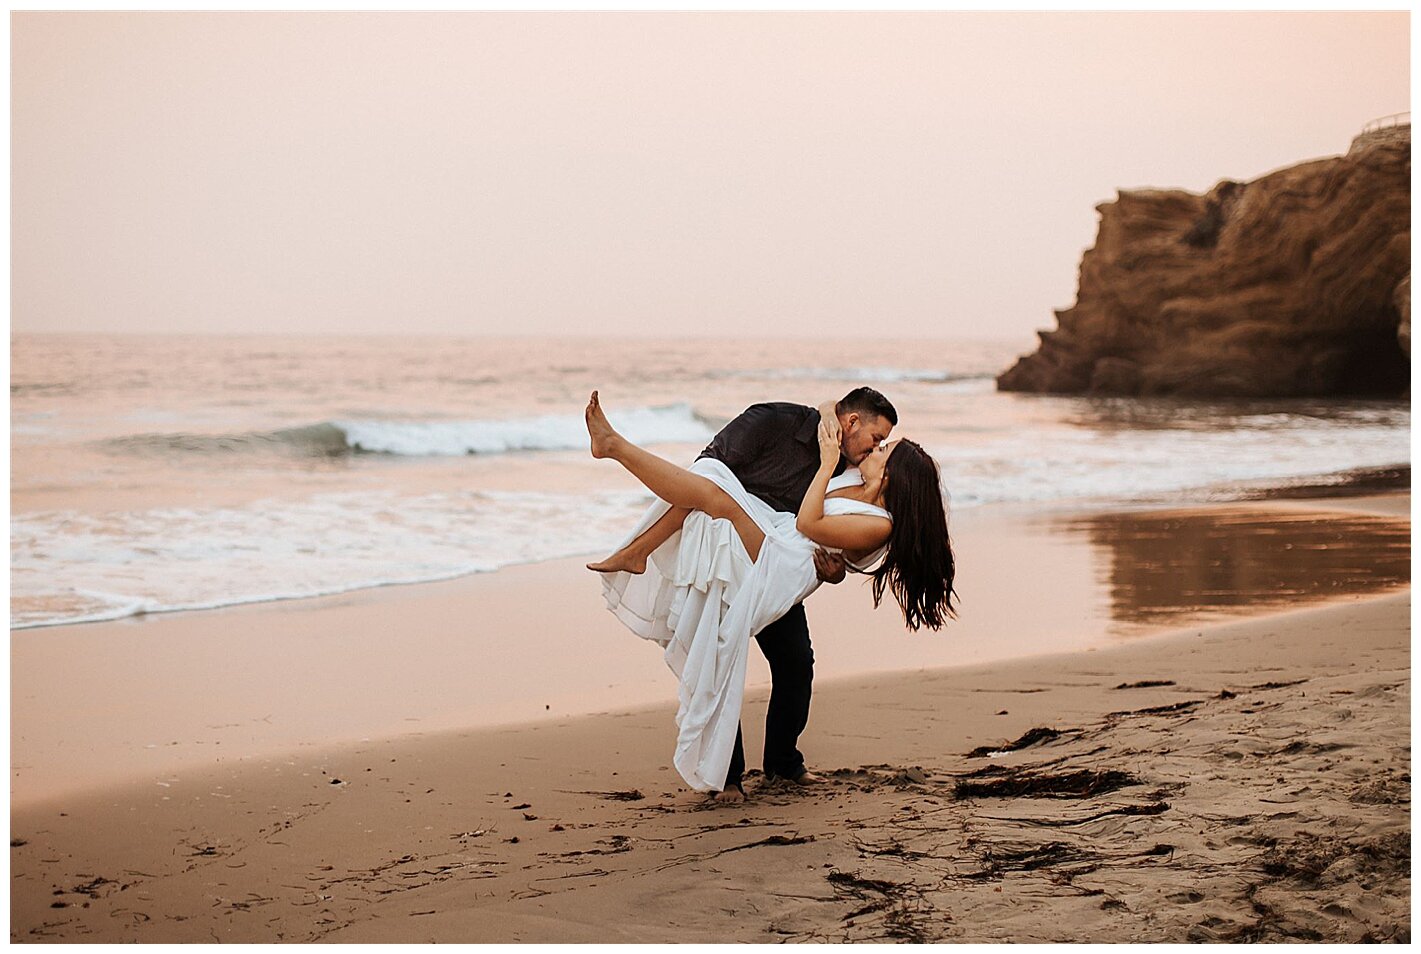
[1059,509,1411,633]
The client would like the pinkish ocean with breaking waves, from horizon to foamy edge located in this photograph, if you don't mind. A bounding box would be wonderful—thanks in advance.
[10,334,1411,628]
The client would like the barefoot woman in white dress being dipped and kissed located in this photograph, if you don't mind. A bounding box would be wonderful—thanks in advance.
[585,391,955,790]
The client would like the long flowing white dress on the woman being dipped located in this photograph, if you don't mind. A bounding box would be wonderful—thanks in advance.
[603,458,888,792]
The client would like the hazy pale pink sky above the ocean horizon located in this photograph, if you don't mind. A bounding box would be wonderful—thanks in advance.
[11,13,1410,340]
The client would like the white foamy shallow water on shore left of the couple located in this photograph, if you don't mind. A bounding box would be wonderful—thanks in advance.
[10,492,651,628]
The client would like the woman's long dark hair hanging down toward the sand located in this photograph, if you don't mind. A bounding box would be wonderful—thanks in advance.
[872,438,958,630]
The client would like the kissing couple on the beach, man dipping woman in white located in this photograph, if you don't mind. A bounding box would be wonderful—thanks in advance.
[585,388,955,802]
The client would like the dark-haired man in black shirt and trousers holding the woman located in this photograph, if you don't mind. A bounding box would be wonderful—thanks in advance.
[693,388,898,802]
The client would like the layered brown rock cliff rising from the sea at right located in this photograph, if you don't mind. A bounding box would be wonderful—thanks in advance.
[998,127,1411,397]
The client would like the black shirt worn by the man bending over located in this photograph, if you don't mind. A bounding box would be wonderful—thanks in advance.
[701,402,845,513]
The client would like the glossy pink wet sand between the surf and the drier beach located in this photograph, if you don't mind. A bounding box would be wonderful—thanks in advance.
[11,493,1410,806]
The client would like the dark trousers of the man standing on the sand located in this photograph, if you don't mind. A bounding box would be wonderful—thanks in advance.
[725,603,814,788]
